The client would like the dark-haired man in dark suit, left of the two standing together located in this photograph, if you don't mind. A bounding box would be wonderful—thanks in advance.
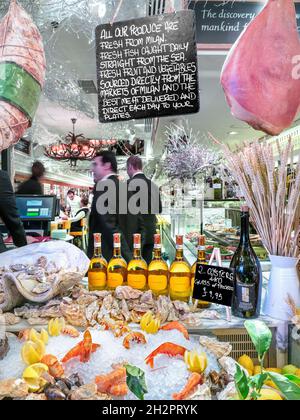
[88,151,132,262]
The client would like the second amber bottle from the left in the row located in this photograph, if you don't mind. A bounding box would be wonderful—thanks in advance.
[107,233,127,290]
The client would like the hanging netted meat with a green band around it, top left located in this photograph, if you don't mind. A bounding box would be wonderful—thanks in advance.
[0,0,46,152]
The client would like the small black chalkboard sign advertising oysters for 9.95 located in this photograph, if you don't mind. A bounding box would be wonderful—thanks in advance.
[193,264,235,307]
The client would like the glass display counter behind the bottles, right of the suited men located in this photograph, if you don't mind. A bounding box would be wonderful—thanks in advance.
[162,199,270,271]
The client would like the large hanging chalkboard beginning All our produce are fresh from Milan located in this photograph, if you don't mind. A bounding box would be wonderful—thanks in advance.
[96,11,199,123]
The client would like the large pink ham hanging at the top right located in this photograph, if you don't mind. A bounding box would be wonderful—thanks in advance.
[221,0,300,135]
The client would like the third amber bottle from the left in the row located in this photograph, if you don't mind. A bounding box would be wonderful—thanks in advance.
[127,233,148,290]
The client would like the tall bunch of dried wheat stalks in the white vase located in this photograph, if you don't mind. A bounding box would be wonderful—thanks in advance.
[210,134,300,257]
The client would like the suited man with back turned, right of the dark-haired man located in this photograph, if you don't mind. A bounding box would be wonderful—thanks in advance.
[127,156,162,264]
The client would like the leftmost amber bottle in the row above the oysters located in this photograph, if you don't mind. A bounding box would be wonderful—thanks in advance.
[88,233,107,291]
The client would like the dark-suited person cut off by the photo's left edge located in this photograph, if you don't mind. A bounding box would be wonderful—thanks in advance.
[0,171,27,253]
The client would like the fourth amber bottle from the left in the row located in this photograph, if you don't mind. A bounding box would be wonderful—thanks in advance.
[148,234,169,296]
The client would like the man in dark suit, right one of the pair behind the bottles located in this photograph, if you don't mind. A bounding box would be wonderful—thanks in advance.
[127,156,162,264]
